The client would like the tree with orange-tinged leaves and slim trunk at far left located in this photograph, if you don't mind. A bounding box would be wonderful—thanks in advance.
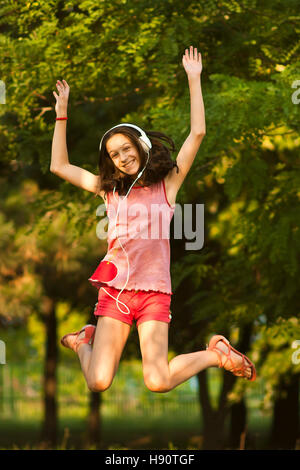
[0,180,109,445]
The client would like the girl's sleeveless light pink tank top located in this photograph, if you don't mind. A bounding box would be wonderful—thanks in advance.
[89,180,175,295]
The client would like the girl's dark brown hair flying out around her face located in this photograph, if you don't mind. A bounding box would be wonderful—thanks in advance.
[94,126,179,195]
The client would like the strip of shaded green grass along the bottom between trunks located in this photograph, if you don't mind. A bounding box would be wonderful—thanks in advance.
[0,415,270,450]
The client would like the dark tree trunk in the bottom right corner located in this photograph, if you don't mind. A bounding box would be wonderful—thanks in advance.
[270,374,299,449]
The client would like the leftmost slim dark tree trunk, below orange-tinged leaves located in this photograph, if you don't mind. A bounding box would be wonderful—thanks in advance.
[42,301,58,446]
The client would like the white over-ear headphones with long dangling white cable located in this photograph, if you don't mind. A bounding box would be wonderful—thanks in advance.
[96,123,152,315]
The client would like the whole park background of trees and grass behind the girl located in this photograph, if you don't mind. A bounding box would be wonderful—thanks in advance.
[0,0,300,449]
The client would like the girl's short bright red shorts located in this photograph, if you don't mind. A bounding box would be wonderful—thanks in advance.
[94,286,172,326]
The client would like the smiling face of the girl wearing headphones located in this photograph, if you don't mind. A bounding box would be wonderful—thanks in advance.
[106,134,140,175]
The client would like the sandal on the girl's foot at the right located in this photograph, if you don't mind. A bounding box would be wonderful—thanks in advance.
[206,335,256,382]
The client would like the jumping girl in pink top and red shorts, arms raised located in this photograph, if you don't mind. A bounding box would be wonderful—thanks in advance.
[50,46,256,392]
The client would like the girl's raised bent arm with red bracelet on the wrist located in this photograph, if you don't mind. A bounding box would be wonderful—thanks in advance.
[50,80,104,198]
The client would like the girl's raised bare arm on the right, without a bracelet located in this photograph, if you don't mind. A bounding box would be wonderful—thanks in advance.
[165,46,206,200]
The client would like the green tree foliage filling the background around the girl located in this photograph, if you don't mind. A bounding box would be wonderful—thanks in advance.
[0,0,300,436]
